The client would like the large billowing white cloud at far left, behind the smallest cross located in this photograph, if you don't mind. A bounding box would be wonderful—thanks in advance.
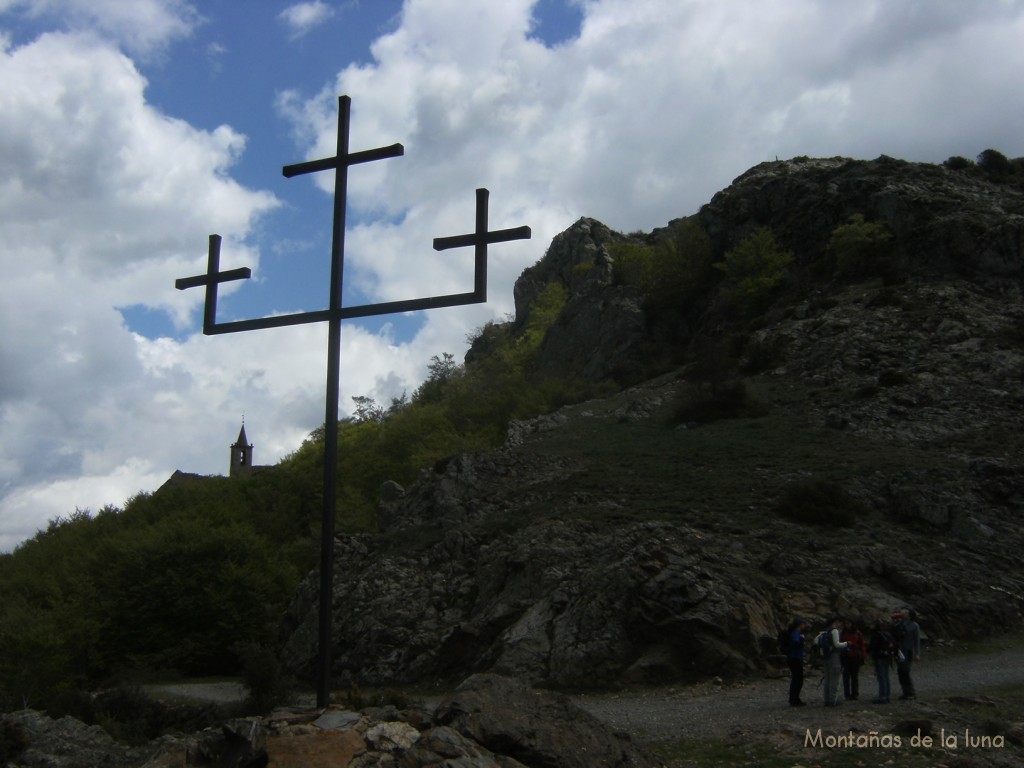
[0,34,276,546]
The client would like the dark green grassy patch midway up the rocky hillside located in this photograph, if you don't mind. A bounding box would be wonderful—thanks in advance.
[503,374,940,532]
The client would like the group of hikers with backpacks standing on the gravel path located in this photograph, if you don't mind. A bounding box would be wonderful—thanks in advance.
[778,609,921,707]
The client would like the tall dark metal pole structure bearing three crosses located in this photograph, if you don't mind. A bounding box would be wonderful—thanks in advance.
[174,96,530,708]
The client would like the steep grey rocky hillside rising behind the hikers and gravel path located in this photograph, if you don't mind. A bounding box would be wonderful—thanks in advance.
[286,157,1024,688]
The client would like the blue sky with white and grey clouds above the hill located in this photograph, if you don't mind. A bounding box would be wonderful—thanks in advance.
[0,0,1024,551]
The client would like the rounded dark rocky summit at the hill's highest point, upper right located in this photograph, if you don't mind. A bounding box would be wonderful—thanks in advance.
[698,156,1024,286]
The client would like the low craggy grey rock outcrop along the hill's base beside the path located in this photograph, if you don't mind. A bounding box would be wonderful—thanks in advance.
[280,512,775,687]
